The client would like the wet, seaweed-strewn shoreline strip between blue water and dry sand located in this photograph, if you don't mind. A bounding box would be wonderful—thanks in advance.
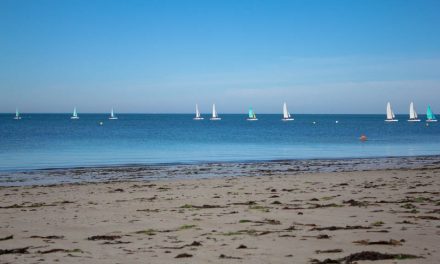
[0,155,440,187]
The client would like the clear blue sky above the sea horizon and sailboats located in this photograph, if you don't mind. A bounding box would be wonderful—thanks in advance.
[0,0,440,114]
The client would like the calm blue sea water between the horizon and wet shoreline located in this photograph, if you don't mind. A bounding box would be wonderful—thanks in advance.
[0,114,440,171]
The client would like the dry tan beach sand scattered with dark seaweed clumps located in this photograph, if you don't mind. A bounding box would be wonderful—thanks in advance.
[0,167,440,264]
